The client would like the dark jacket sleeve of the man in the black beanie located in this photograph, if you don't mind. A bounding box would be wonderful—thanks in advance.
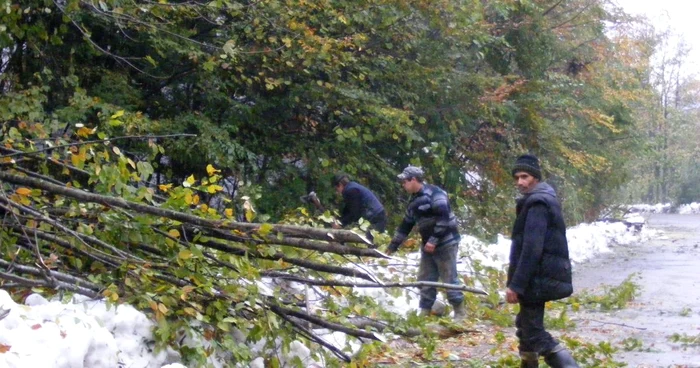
[508,204,548,295]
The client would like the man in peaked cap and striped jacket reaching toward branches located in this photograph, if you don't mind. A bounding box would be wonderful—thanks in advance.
[387,165,466,322]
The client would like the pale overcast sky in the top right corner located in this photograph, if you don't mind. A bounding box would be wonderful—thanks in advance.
[617,0,700,74]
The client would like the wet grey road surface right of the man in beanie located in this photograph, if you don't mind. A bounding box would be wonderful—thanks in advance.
[571,214,700,368]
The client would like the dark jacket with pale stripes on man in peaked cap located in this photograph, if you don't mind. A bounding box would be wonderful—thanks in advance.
[388,184,460,252]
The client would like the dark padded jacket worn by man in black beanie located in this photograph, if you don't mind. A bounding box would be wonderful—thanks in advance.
[507,183,573,302]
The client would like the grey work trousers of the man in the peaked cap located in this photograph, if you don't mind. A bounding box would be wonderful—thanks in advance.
[418,243,464,309]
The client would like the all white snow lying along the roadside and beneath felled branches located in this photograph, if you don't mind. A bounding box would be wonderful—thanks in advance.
[0,213,668,368]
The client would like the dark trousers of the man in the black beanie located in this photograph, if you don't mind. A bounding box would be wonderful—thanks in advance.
[515,302,559,355]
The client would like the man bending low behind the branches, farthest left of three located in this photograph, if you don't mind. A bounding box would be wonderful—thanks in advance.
[331,173,386,236]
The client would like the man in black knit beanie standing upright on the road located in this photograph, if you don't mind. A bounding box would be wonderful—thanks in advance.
[506,154,578,368]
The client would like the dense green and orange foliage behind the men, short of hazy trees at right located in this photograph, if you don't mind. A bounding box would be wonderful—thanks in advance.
[0,0,656,232]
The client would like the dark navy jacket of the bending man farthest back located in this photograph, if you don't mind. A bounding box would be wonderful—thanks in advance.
[340,181,386,231]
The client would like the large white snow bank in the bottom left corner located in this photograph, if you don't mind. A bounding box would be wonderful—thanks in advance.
[0,290,180,368]
